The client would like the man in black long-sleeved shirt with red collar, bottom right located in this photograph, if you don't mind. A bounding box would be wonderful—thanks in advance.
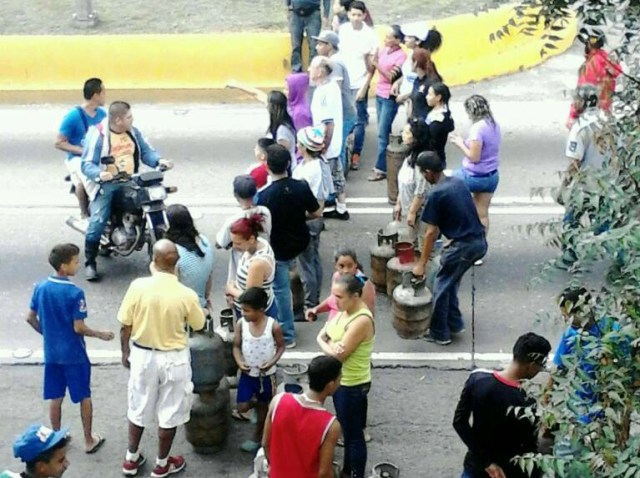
[453,332,551,478]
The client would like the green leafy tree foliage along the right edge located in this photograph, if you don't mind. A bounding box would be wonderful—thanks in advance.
[496,0,640,478]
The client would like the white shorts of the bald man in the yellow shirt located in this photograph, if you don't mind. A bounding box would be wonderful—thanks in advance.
[127,345,193,428]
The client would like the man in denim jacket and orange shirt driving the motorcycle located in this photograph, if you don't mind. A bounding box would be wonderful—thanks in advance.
[82,101,173,281]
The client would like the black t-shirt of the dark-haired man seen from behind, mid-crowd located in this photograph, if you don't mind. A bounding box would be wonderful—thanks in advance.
[258,178,320,261]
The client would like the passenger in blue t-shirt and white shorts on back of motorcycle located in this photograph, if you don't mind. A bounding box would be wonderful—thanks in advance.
[55,78,107,219]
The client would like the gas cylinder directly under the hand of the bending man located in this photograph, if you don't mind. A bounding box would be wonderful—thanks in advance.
[391,271,431,339]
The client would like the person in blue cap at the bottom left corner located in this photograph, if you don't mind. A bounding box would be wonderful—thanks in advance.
[0,425,69,478]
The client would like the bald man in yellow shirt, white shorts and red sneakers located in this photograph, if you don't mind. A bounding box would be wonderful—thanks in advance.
[118,239,205,477]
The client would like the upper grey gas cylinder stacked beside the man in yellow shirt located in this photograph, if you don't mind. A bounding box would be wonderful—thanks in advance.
[189,319,226,393]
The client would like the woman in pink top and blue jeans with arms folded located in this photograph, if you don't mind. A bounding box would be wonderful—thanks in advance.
[368,25,407,181]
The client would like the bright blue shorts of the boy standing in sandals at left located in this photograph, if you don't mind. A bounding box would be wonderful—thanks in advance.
[44,362,91,403]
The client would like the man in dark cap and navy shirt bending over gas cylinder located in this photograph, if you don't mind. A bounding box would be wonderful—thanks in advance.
[413,151,487,345]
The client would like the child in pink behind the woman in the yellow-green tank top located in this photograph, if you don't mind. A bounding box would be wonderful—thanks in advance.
[305,247,376,322]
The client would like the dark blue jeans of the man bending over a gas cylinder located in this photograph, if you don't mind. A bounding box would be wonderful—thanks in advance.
[430,235,487,340]
